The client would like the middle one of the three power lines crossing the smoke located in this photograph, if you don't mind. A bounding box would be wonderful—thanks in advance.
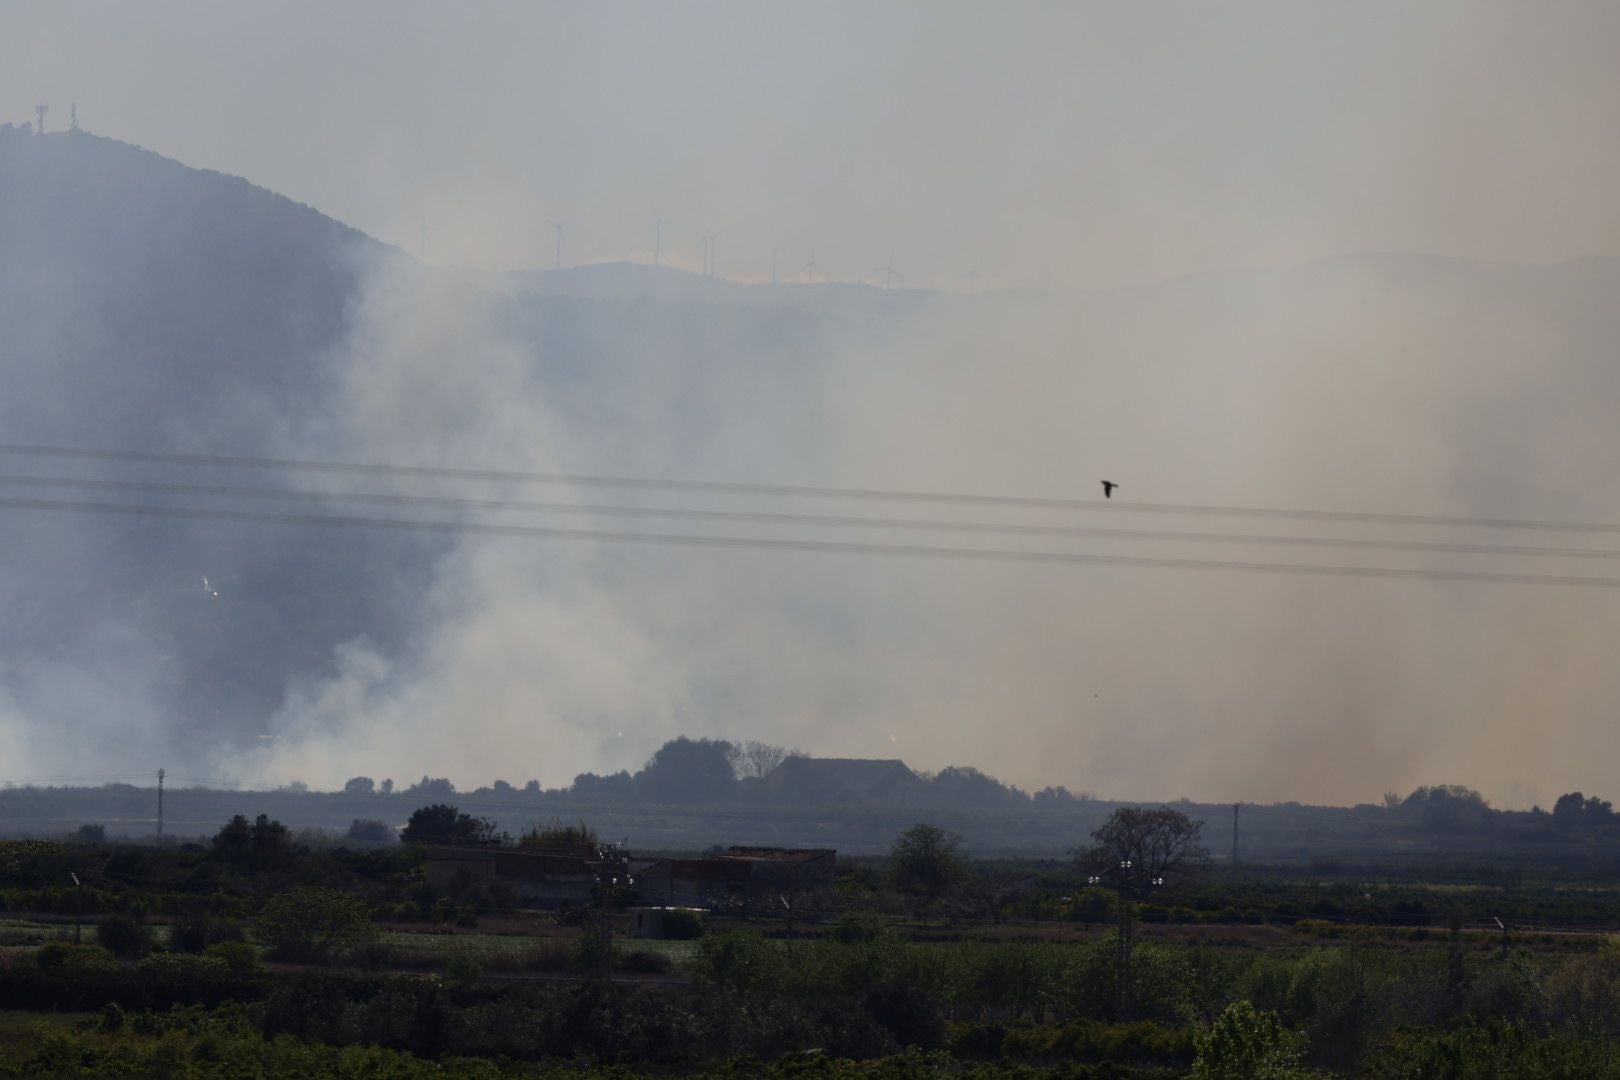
[0,474,1620,559]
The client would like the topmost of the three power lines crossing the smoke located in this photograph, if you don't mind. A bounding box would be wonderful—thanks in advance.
[0,442,1620,533]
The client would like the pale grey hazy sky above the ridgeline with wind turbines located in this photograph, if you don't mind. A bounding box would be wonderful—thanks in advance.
[0,0,1620,288]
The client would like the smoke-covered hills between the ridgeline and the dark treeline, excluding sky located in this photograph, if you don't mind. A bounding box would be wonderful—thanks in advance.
[0,122,1620,805]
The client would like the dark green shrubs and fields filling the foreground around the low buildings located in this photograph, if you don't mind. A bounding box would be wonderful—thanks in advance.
[0,806,1620,1080]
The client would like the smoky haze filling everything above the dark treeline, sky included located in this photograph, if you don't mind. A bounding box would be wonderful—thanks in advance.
[0,3,1620,806]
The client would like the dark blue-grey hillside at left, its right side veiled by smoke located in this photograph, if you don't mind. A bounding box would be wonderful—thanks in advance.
[0,128,421,771]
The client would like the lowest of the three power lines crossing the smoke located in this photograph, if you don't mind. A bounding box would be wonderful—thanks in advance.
[0,497,1620,588]
